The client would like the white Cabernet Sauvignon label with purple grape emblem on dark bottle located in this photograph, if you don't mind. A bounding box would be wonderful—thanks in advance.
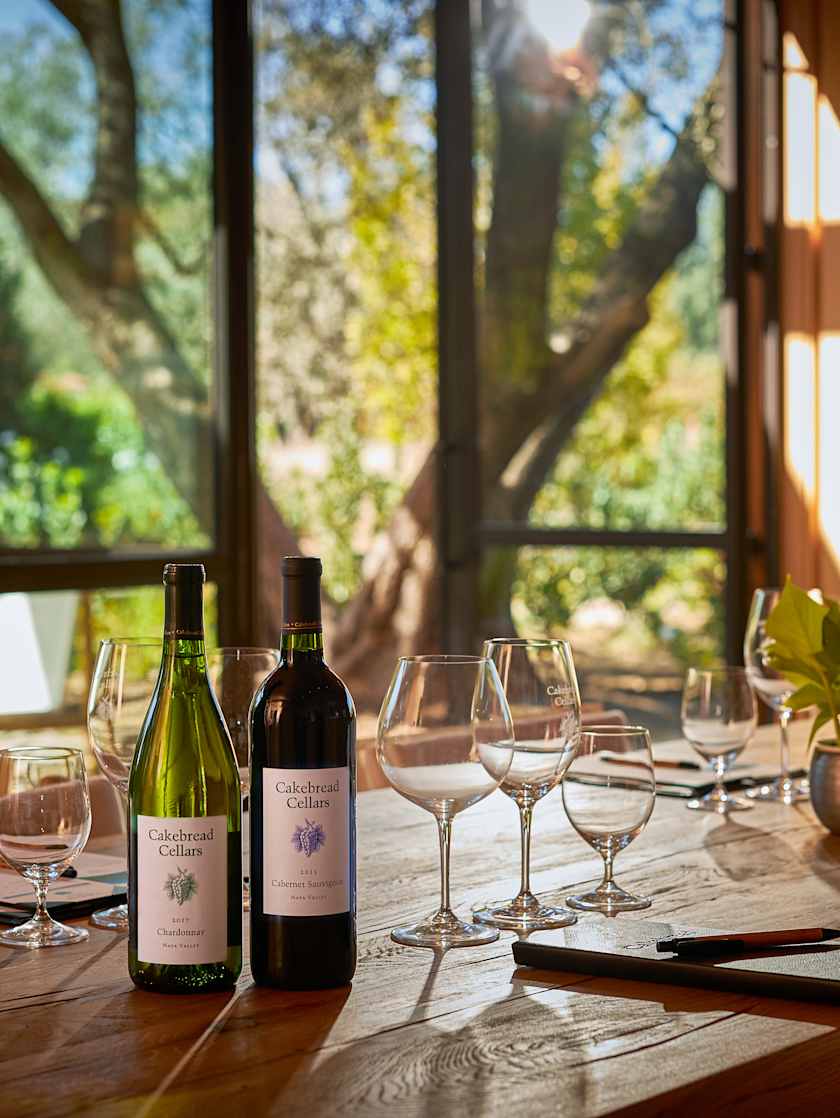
[263,767,350,916]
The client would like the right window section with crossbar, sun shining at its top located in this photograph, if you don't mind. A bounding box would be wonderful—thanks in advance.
[473,0,732,735]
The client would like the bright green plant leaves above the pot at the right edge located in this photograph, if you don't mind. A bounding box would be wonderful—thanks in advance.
[766,575,840,748]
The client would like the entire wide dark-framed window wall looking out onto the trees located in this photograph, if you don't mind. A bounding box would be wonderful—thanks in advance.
[0,0,774,736]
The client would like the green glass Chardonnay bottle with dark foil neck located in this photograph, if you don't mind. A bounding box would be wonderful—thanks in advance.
[129,563,242,994]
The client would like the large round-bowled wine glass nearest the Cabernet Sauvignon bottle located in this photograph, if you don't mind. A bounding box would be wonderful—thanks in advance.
[376,656,513,950]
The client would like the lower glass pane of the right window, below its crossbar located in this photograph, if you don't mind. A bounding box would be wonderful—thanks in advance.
[481,548,726,739]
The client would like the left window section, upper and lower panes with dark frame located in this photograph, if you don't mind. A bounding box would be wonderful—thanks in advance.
[0,0,244,728]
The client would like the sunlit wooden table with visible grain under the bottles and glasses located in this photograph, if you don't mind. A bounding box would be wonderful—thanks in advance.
[0,730,840,1118]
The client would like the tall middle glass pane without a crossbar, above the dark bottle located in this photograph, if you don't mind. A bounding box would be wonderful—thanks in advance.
[256,0,436,736]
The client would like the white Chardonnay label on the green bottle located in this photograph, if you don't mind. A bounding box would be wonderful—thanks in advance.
[138,815,230,966]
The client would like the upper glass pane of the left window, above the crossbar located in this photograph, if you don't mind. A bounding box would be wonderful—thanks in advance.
[0,0,215,551]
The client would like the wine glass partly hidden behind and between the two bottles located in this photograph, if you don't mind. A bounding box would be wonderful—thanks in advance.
[207,647,280,912]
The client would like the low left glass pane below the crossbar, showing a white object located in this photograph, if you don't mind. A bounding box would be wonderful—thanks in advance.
[0,582,218,728]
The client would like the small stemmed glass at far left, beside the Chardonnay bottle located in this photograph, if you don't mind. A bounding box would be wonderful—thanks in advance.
[0,746,91,947]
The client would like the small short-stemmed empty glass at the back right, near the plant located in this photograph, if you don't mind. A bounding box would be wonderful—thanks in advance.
[680,667,757,815]
